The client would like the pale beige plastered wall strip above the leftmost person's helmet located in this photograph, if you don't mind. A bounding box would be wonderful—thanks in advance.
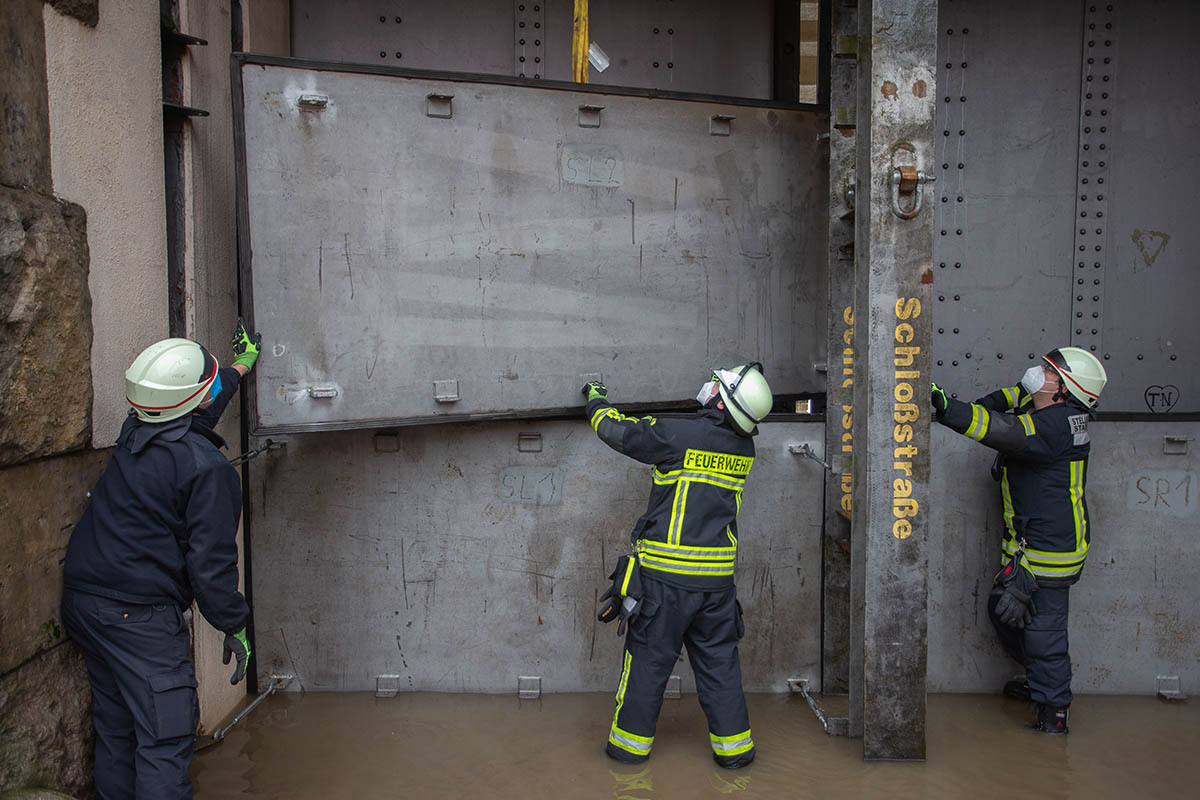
[43,0,169,447]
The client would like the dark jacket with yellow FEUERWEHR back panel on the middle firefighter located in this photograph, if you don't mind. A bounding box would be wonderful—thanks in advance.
[588,398,755,590]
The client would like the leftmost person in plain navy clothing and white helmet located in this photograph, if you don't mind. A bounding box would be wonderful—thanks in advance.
[62,320,259,800]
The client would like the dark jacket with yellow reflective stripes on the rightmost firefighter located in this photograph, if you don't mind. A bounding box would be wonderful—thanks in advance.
[938,386,1092,587]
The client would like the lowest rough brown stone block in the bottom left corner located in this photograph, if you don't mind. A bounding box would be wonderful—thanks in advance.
[0,642,94,799]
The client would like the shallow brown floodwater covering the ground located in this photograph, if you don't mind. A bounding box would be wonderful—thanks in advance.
[192,693,1200,800]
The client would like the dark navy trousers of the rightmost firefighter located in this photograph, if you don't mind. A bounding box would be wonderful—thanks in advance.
[988,587,1072,708]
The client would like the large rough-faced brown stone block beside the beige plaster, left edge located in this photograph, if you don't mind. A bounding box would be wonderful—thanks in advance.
[0,186,91,465]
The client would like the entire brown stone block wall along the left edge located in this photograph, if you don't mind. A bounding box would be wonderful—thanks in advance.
[0,0,97,798]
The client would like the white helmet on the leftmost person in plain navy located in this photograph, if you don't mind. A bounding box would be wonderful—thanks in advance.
[125,339,218,422]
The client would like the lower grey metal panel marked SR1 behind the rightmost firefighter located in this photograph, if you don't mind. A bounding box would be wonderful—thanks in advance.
[929,419,1200,694]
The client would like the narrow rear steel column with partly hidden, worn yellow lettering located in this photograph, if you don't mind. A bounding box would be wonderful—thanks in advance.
[821,0,858,694]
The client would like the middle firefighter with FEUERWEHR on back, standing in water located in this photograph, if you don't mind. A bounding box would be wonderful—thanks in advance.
[583,363,772,769]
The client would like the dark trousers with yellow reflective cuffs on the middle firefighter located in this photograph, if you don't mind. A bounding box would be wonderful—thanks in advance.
[607,571,755,766]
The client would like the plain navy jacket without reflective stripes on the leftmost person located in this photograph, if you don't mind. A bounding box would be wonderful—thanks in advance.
[64,368,248,633]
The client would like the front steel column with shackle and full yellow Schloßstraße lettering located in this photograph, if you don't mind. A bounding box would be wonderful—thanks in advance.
[850,0,937,759]
